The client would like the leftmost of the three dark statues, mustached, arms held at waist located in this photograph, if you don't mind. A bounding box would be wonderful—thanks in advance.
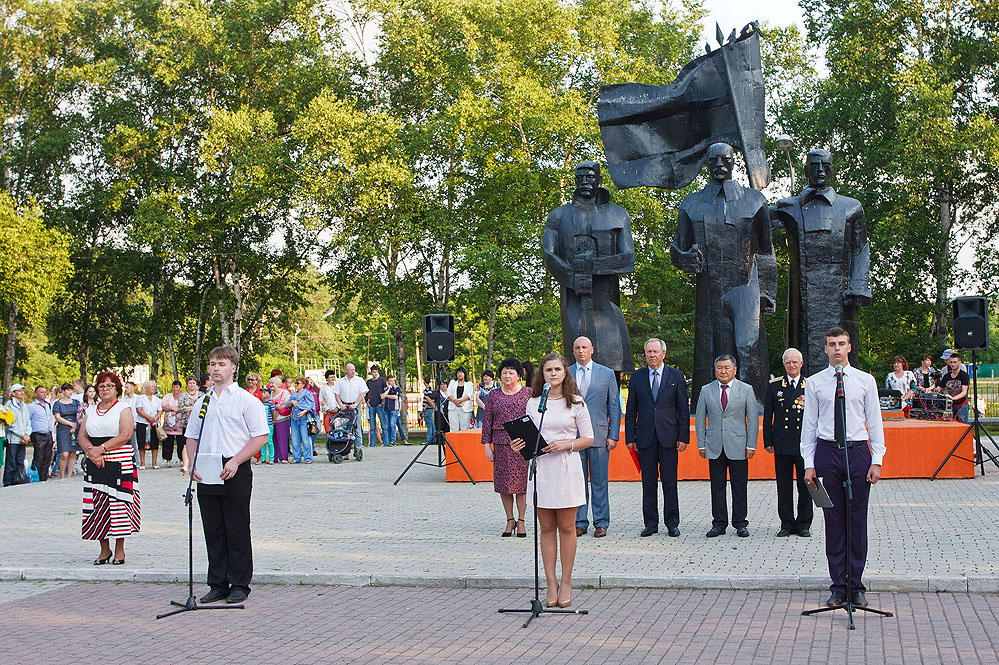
[541,162,635,372]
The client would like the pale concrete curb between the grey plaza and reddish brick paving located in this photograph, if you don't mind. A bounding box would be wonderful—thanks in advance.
[0,567,984,594]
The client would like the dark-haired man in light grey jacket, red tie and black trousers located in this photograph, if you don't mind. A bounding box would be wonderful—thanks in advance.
[694,354,760,538]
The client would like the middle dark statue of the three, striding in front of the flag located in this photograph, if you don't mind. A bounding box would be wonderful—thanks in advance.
[669,143,777,404]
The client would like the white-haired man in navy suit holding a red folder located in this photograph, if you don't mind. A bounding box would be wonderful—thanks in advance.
[624,338,690,538]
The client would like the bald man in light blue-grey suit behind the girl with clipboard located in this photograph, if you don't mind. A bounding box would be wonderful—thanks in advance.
[569,337,621,538]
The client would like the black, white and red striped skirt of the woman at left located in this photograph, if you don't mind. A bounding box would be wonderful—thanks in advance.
[82,437,140,540]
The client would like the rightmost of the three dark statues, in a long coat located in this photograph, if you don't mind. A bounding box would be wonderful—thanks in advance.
[770,150,871,376]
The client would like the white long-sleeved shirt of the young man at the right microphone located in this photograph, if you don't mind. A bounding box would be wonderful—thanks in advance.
[801,365,885,469]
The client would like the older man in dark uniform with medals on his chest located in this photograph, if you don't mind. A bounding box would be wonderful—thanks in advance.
[763,348,812,538]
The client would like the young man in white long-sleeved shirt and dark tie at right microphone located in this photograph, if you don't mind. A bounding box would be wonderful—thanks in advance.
[801,327,885,607]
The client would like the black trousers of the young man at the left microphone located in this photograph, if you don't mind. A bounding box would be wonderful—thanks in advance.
[198,457,253,593]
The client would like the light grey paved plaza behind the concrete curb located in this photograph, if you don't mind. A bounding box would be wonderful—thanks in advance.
[0,446,999,592]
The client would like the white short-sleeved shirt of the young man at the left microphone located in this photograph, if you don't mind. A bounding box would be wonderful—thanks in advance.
[184,382,270,457]
